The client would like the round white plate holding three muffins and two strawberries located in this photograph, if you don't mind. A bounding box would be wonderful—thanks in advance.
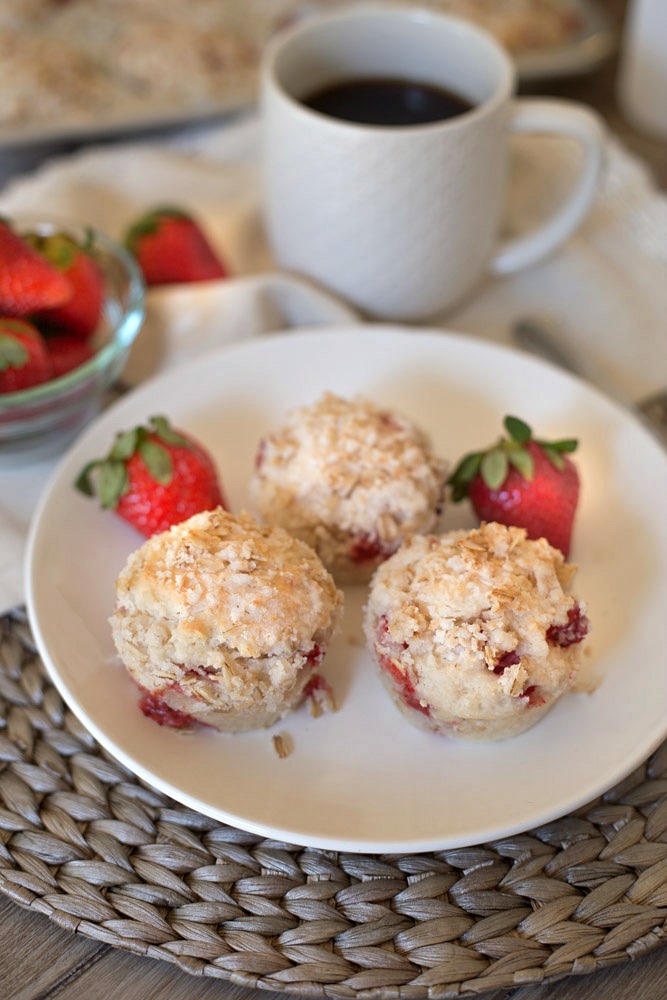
[26,325,667,853]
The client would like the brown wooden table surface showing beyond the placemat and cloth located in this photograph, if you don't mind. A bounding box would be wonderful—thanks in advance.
[0,0,667,1000]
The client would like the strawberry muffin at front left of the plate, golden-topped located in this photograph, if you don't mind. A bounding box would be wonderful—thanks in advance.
[111,507,342,732]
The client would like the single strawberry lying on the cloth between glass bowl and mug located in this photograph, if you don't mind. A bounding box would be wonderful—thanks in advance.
[125,208,227,285]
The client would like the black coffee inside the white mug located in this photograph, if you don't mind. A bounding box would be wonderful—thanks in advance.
[303,77,473,125]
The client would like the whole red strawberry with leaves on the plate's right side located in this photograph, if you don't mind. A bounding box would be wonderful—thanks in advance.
[449,417,579,558]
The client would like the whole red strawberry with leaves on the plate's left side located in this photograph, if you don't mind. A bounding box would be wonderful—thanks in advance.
[75,417,225,537]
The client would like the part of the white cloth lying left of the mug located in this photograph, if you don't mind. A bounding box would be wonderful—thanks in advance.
[0,129,358,613]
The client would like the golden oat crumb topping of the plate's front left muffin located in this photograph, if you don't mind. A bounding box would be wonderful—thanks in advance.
[118,508,340,662]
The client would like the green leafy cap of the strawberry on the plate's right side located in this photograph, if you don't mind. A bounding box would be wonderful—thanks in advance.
[449,416,578,503]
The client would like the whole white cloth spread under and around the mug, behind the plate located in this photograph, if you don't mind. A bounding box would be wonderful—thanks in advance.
[0,109,667,611]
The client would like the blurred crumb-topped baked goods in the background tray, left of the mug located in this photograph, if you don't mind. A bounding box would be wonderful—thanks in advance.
[0,0,260,127]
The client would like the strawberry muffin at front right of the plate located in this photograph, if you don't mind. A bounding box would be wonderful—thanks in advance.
[364,523,589,740]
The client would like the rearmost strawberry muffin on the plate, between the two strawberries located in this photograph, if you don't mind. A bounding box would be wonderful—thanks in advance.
[250,393,446,583]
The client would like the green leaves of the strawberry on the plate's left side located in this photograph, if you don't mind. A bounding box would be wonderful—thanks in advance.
[74,416,192,510]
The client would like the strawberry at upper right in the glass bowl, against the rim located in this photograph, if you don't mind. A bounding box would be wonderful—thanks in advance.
[26,233,104,340]
